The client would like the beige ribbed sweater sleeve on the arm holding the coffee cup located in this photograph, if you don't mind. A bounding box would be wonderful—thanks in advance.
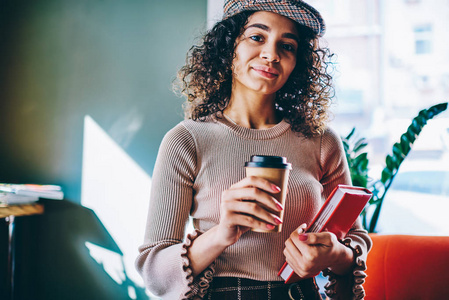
[136,123,211,299]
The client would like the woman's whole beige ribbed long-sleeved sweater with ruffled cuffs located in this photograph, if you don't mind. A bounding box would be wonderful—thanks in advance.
[136,117,370,299]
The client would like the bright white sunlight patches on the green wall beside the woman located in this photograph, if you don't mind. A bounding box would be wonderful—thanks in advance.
[81,116,151,286]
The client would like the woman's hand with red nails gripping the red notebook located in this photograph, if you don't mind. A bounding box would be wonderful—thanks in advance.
[284,224,354,278]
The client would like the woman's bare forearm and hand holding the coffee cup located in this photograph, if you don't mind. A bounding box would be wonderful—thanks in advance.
[188,177,283,276]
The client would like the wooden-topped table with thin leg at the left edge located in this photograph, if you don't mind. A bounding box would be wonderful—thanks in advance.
[0,203,44,299]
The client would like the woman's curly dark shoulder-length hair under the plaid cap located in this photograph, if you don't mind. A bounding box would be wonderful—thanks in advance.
[178,11,334,137]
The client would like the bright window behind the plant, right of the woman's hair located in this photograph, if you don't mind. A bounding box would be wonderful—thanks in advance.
[311,0,449,235]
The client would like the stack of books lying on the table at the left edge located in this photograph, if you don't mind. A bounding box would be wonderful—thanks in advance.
[0,183,64,205]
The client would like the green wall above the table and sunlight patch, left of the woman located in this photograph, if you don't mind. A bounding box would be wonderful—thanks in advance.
[0,0,206,202]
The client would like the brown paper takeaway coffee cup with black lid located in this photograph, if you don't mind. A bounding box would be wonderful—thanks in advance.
[245,155,292,232]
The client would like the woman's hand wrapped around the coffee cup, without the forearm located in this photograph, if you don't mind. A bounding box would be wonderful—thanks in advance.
[217,176,283,246]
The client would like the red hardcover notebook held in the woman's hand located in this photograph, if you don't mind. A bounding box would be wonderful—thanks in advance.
[278,185,372,283]
